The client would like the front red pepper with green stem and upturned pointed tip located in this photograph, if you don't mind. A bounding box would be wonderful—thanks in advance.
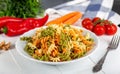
[2,14,48,36]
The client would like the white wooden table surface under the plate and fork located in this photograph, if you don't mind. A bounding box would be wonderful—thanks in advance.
[0,0,120,74]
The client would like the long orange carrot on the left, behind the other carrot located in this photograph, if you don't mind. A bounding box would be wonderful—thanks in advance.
[46,11,80,25]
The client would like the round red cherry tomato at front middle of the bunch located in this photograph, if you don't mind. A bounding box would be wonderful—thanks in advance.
[93,24,105,36]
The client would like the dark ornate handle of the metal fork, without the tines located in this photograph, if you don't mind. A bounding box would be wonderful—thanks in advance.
[93,49,109,72]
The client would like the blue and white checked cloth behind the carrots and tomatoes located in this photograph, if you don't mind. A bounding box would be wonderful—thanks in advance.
[46,0,120,24]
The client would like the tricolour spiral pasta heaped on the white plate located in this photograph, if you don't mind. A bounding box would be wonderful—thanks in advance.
[20,24,94,62]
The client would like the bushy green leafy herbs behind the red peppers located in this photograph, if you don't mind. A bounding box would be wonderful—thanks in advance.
[0,0,44,18]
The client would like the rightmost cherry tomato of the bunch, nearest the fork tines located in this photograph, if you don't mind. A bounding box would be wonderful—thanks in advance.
[105,24,117,35]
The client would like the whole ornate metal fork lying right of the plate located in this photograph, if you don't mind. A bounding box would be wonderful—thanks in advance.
[93,35,120,72]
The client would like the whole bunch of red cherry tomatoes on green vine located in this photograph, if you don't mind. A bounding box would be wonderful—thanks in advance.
[82,17,117,36]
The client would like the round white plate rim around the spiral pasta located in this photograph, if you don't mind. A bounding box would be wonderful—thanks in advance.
[15,26,99,65]
